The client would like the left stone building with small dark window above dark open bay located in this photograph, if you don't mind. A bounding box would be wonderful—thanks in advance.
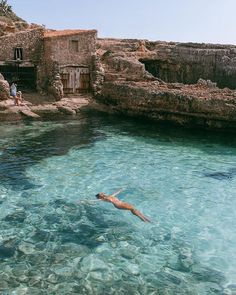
[0,28,44,89]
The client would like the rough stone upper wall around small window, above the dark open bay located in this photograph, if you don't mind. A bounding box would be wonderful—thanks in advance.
[0,28,44,64]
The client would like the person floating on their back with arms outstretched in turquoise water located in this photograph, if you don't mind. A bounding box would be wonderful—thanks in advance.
[96,190,150,222]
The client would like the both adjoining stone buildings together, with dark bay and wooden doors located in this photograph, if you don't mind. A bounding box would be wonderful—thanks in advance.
[0,27,97,93]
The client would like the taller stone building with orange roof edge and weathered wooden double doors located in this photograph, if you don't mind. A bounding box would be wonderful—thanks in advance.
[41,30,97,93]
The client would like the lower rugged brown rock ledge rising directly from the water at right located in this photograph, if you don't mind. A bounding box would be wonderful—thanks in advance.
[96,81,236,128]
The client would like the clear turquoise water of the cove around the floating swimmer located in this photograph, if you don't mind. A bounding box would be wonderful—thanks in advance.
[0,114,236,294]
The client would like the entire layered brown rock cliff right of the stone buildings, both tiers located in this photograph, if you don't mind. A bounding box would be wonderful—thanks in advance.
[95,39,236,128]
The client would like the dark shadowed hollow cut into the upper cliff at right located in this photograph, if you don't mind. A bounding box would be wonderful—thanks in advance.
[139,59,236,89]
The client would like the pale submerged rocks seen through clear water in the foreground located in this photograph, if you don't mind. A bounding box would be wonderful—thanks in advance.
[0,201,229,295]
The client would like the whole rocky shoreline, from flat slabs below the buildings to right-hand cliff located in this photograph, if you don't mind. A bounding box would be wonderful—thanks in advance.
[0,21,236,130]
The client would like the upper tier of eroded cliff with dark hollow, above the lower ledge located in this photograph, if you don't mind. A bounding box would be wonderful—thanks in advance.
[97,39,236,89]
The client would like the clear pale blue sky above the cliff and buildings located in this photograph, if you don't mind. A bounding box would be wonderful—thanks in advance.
[8,0,236,44]
